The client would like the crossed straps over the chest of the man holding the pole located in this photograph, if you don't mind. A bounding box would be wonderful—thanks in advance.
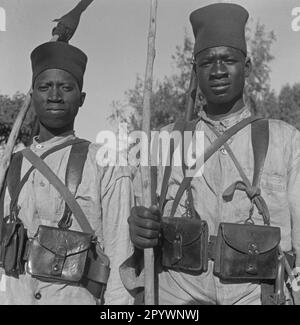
[159,117,270,225]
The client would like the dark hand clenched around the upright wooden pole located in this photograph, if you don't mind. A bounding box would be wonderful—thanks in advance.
[128,206,161,249]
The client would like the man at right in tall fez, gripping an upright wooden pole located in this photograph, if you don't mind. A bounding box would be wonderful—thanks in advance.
[123,3,300,305]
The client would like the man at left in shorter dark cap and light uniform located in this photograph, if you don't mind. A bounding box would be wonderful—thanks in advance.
[0,42,132,305]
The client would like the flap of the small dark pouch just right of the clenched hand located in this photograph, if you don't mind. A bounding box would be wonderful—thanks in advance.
[162,217,206,246]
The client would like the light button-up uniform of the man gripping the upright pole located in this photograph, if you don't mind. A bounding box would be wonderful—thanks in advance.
[122,107,300,304]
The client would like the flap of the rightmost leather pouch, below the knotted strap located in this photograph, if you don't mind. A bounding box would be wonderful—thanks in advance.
[219,223,280,255]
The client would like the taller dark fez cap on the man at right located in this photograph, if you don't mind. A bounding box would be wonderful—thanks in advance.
[190,3,249,57]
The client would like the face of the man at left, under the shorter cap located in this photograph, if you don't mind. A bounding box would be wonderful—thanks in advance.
[32,69,85,129]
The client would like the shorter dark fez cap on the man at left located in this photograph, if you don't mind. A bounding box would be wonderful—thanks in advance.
[31,42,87,90]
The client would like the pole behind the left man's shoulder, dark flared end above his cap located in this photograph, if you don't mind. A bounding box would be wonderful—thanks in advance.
[0,0,93,192]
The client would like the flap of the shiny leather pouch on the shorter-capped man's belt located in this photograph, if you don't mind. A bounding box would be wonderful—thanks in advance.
[35,226,92,256]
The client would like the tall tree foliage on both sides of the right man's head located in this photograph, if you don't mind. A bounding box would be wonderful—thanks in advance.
[109,21,290,129]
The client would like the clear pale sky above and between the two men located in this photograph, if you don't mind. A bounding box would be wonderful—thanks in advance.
[0,0,300,141]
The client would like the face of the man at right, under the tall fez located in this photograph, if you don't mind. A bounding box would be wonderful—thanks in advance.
[196,46,251,105]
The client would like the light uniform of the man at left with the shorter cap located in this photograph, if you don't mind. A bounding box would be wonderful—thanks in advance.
[0,134,133,305]
